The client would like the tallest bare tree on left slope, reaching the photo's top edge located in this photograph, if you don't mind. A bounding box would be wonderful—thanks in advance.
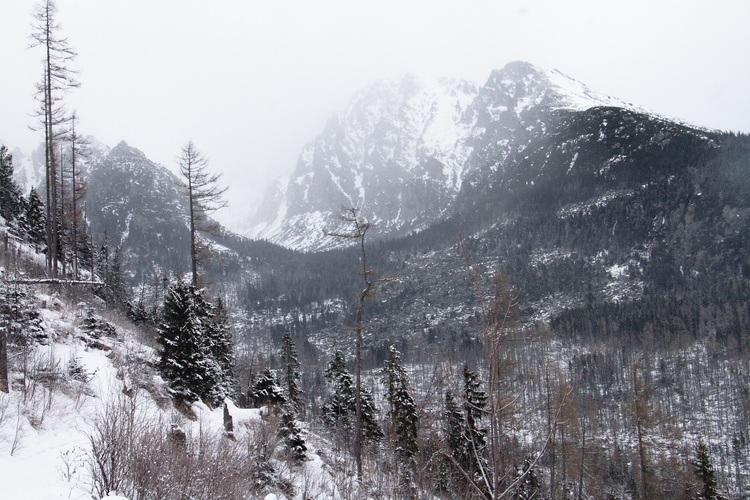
[31,0,80,276]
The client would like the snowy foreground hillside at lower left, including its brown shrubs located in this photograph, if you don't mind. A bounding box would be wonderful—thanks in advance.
[0,225,350,500]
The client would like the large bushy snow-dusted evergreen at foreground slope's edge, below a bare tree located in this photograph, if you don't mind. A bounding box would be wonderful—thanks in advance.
[157,281,224,405]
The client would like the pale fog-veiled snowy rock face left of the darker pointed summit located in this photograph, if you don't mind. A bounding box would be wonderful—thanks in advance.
[250,76,477,250]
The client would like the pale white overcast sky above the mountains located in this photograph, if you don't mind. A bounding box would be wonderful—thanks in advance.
[0,0,750,229]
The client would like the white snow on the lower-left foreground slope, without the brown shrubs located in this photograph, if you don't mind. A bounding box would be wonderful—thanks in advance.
[0,294,339,500]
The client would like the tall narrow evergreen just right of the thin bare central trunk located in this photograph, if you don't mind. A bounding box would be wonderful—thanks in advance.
[383,345,419,498]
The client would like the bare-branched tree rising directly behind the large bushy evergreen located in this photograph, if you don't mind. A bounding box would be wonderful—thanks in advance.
[177,140,227,286]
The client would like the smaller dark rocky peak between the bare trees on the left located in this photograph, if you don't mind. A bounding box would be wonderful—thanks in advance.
[86,142,190,282]
